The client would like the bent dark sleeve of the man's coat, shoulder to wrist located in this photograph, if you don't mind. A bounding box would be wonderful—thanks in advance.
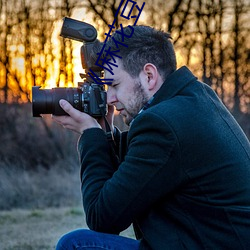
[78,112,186,234]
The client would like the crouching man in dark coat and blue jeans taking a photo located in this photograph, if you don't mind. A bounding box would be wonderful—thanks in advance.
[54,26,250,250]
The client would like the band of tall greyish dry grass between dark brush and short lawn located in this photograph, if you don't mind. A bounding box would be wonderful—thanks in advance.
[0,162,81,210]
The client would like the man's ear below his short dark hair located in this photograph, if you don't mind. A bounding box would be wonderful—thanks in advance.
[143,63,159,90]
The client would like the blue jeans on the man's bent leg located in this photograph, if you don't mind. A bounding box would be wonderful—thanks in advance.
[56,229,140,250]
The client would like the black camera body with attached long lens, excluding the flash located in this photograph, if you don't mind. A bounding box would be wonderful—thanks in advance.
[32,82,107,118]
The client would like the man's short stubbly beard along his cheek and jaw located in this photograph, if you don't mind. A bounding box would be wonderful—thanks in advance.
[124,80,149,125]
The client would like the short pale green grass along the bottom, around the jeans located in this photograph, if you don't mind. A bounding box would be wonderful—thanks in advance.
[0,207,134,250]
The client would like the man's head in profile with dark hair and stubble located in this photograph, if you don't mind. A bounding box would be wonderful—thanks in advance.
[105,26,176,124]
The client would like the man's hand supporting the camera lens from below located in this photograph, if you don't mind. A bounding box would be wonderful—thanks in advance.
[52,100,101,134]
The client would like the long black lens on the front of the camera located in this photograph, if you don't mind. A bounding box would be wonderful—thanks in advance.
[32,86,82,117]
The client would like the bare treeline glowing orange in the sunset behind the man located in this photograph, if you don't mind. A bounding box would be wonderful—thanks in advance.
[0,0,250,116]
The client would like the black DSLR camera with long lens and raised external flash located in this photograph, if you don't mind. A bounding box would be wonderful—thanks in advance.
[32,17,107,118]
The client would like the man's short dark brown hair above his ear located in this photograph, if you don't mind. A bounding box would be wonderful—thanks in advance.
[106,25,176,80]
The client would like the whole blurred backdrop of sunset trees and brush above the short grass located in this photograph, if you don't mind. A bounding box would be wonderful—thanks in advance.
[0,0,250,210]
